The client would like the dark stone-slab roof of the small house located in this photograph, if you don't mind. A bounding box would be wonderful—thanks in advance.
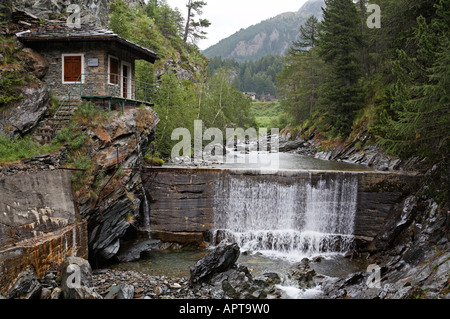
[16,21,159,63]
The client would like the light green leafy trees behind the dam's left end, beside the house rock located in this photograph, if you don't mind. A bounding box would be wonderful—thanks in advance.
[154,69,256,157]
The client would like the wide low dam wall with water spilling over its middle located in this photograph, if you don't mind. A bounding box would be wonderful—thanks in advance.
[143,167,417,255]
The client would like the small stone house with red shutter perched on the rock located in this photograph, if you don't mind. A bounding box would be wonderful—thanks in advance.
[16,22,158,105]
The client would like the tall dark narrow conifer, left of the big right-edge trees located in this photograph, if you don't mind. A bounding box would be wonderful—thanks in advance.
[318,0,362,136]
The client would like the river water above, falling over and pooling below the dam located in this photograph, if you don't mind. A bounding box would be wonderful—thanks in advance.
[110,152,371,298]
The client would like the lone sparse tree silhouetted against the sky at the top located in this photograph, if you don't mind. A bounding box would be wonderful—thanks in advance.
[183,0,211,43]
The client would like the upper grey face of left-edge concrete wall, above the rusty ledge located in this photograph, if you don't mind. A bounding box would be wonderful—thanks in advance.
[0,170,76,247]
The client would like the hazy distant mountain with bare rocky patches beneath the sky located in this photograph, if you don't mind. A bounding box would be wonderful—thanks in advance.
[203,0,325,62]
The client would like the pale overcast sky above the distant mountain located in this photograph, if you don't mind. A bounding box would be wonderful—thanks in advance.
[167,0,307,50]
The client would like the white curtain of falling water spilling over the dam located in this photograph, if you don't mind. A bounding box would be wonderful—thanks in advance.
[214,173,358,257]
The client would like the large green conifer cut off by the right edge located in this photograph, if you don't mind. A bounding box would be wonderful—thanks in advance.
[378,0,450,159]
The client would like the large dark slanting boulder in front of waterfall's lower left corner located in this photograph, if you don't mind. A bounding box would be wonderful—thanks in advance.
[190,244,240,286]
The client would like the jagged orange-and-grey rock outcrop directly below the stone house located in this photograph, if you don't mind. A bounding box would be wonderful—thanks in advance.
[76,108,158,261]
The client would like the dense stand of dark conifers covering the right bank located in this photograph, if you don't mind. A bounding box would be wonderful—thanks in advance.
[279,0,450,157]
